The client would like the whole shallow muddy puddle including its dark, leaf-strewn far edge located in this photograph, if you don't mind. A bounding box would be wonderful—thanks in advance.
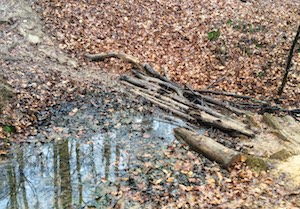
[0,94,203,208]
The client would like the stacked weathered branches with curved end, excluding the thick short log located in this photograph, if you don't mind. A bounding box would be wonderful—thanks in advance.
[86,52,254,137]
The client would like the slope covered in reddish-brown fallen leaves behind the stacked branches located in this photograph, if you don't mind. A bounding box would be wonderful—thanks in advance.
[37,0,300,107]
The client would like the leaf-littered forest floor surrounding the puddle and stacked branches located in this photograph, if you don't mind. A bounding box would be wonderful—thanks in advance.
[0,0,300,208]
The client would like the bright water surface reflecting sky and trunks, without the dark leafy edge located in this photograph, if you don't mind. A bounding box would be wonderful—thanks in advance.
[0,118,183,209]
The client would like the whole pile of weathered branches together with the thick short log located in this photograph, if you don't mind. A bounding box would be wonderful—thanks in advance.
[85,52,272,168]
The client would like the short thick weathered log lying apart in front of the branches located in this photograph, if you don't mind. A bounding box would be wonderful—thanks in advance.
[173,128,246,168]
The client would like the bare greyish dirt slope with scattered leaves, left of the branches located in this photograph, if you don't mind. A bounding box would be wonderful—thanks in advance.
[0,0,119,139]
